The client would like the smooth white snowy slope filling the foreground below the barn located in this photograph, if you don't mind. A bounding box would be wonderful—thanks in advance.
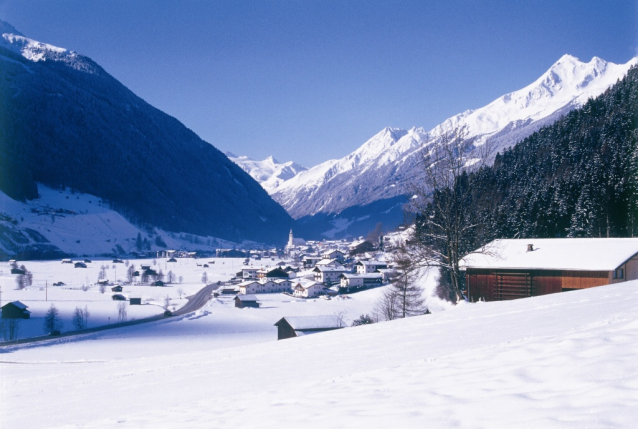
[0,282,638,429]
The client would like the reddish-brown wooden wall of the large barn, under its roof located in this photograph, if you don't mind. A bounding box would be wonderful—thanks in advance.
[466,268,610,302]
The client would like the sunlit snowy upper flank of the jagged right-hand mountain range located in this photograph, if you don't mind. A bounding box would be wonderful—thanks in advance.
[272,55,638,219]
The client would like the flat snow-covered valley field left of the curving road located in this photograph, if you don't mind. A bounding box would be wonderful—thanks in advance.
[0,258,318,338]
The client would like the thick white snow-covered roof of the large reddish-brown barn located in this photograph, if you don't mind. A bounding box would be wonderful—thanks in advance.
[461,238,638,271]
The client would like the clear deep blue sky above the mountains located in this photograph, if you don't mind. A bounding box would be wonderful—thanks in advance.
[0,0,638,166]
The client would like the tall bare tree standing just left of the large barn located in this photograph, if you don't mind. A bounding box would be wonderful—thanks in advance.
[400,127,491,302]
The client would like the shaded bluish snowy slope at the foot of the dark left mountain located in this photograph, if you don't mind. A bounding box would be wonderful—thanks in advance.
[0,184,242,259]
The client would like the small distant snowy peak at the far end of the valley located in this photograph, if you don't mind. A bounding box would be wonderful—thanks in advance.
[226,152,307,194]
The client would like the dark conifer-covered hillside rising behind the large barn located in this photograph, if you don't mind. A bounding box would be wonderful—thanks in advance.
[470,67,638,245]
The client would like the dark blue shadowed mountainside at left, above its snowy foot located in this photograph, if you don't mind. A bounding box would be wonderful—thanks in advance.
[0,21,293,253]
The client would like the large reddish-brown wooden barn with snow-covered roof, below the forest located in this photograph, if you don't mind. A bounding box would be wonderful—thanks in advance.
[462,238,638,301]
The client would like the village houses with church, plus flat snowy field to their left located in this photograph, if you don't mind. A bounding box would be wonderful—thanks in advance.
[0,231,410,342]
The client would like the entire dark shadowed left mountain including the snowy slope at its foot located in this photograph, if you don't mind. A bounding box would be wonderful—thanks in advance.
[0,21,293,257]
